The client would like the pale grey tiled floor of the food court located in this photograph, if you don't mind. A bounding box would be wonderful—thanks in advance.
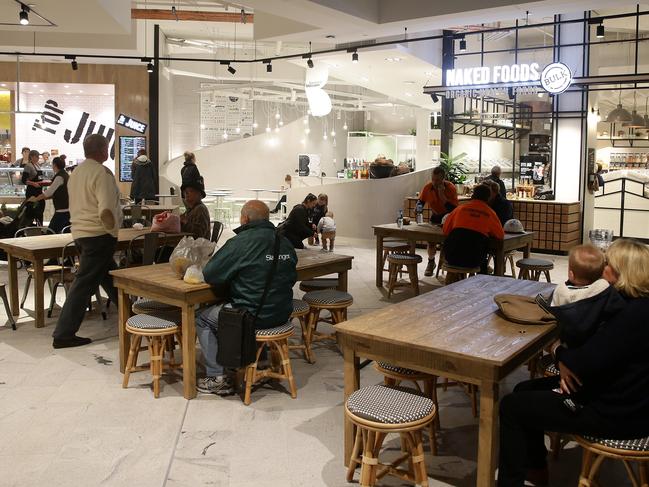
[0,235,630,487]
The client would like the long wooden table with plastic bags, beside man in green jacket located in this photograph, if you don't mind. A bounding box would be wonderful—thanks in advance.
[111,250,353,399]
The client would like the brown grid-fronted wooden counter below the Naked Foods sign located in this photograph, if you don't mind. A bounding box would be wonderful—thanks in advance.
[403,196,581,253]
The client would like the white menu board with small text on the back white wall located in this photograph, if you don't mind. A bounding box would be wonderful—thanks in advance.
[200,83,254,146]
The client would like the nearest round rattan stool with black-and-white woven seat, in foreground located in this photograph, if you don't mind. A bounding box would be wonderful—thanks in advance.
[345,385,437,487]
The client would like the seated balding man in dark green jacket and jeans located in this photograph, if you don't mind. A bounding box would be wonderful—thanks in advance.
[196,200,297,395]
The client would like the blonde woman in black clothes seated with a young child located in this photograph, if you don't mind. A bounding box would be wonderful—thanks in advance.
[498,239,649,487]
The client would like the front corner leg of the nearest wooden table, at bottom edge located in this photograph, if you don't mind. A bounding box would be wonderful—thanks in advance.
[476,381,498,487]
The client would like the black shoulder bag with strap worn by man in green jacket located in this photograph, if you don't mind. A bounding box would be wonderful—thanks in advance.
[216,232,280,368]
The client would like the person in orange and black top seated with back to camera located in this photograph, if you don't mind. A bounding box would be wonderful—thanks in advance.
[443,184,505,272]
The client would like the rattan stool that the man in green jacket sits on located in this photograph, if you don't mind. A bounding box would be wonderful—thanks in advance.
[243,322,297,406]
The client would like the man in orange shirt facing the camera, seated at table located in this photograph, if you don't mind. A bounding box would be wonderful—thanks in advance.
[417,167,459,277]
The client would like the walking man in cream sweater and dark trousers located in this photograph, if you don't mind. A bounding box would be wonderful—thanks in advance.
[52,134,122,348]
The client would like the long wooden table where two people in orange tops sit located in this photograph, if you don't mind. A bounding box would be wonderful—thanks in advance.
[372,223,534,287]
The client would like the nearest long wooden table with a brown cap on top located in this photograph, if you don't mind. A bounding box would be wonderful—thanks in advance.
[336,275,557,487]
